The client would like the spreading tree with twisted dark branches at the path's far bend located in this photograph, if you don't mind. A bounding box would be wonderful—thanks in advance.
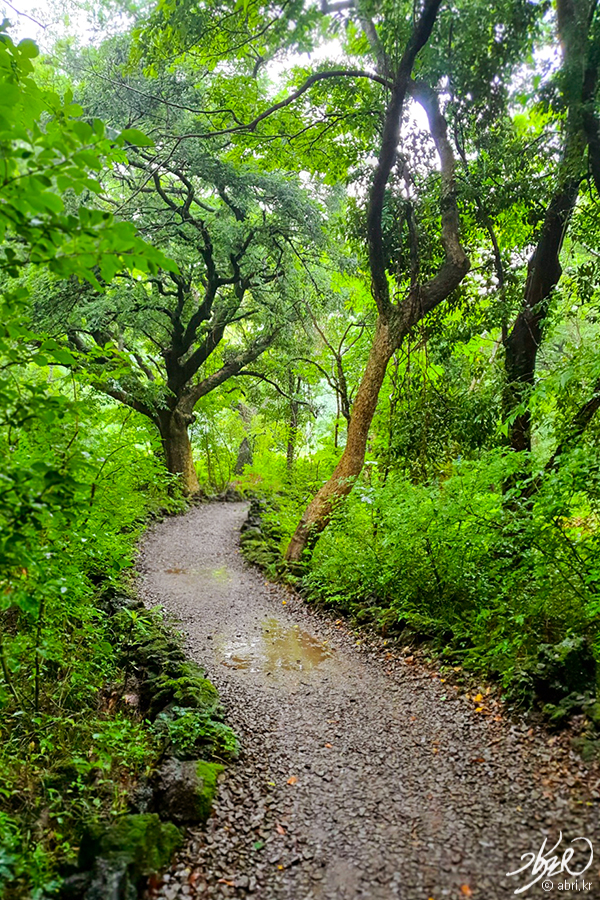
[37,46,321,494]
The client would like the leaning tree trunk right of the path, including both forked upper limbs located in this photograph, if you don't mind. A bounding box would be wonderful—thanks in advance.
[286,0,469,562]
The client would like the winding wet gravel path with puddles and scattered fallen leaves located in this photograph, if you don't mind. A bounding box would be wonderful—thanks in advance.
[140,503,600,900]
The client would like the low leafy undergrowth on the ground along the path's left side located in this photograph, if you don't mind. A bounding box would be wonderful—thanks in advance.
[0,394,230,900]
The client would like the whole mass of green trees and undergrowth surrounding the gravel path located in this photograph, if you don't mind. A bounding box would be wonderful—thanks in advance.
[0,0,600,897]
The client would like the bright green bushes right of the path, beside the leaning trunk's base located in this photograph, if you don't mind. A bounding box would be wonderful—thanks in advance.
[304,451,600,687]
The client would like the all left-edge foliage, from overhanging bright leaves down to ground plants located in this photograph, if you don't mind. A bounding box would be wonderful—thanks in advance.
[0,24,236,897]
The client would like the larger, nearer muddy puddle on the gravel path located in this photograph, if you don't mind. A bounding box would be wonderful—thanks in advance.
[216,618,334,672]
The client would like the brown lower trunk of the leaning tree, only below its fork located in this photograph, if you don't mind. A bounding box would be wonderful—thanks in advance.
[285,317,396,562]
